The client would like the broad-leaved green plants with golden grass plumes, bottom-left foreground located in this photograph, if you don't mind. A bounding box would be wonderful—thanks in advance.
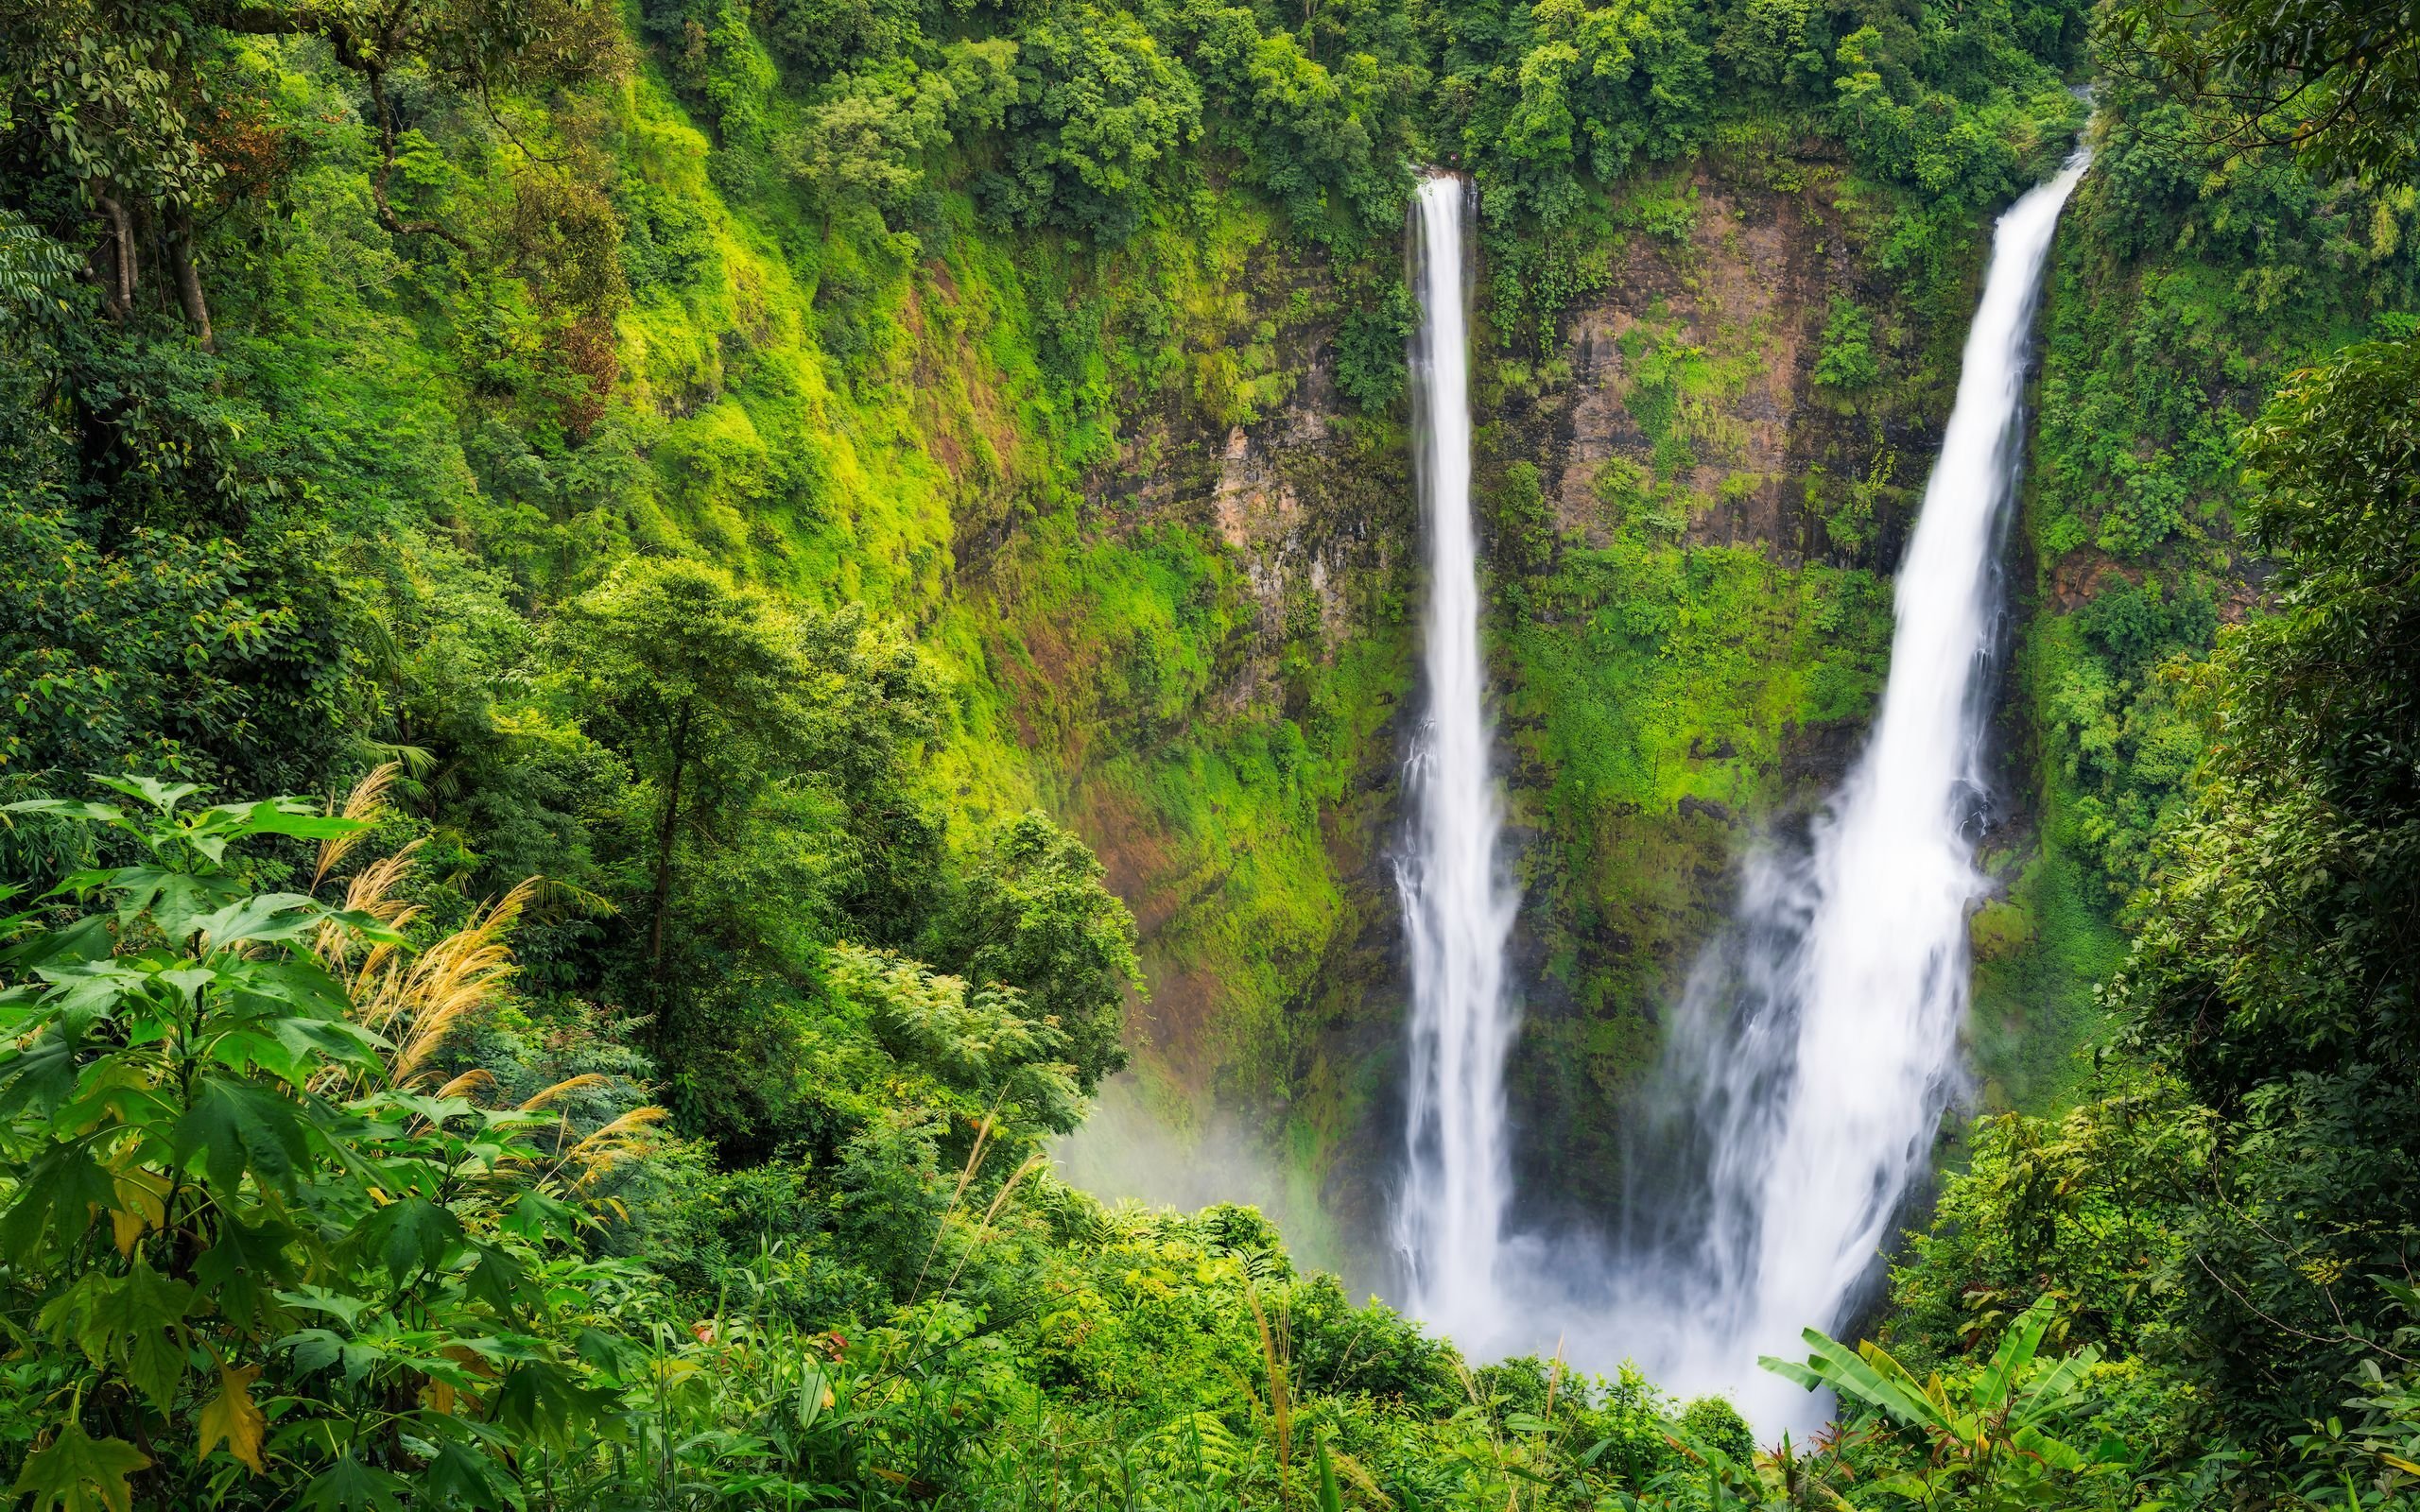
[0,779,644,1512]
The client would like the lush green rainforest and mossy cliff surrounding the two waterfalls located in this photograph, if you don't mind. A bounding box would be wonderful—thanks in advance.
[0,0,2420,1512]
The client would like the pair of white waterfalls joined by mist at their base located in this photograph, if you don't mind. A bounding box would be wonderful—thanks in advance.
[1396,150,2086,1433]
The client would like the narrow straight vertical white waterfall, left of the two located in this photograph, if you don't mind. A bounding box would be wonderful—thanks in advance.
[1394,174,1517,1355]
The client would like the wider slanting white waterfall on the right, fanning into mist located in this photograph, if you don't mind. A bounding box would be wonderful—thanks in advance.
[1616,150,2086,1433]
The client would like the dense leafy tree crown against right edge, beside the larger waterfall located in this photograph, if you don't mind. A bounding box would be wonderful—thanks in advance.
[2125,341,2420,1108]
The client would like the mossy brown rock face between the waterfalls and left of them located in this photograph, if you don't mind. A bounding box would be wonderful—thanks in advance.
[1016,157,1972,1278]
